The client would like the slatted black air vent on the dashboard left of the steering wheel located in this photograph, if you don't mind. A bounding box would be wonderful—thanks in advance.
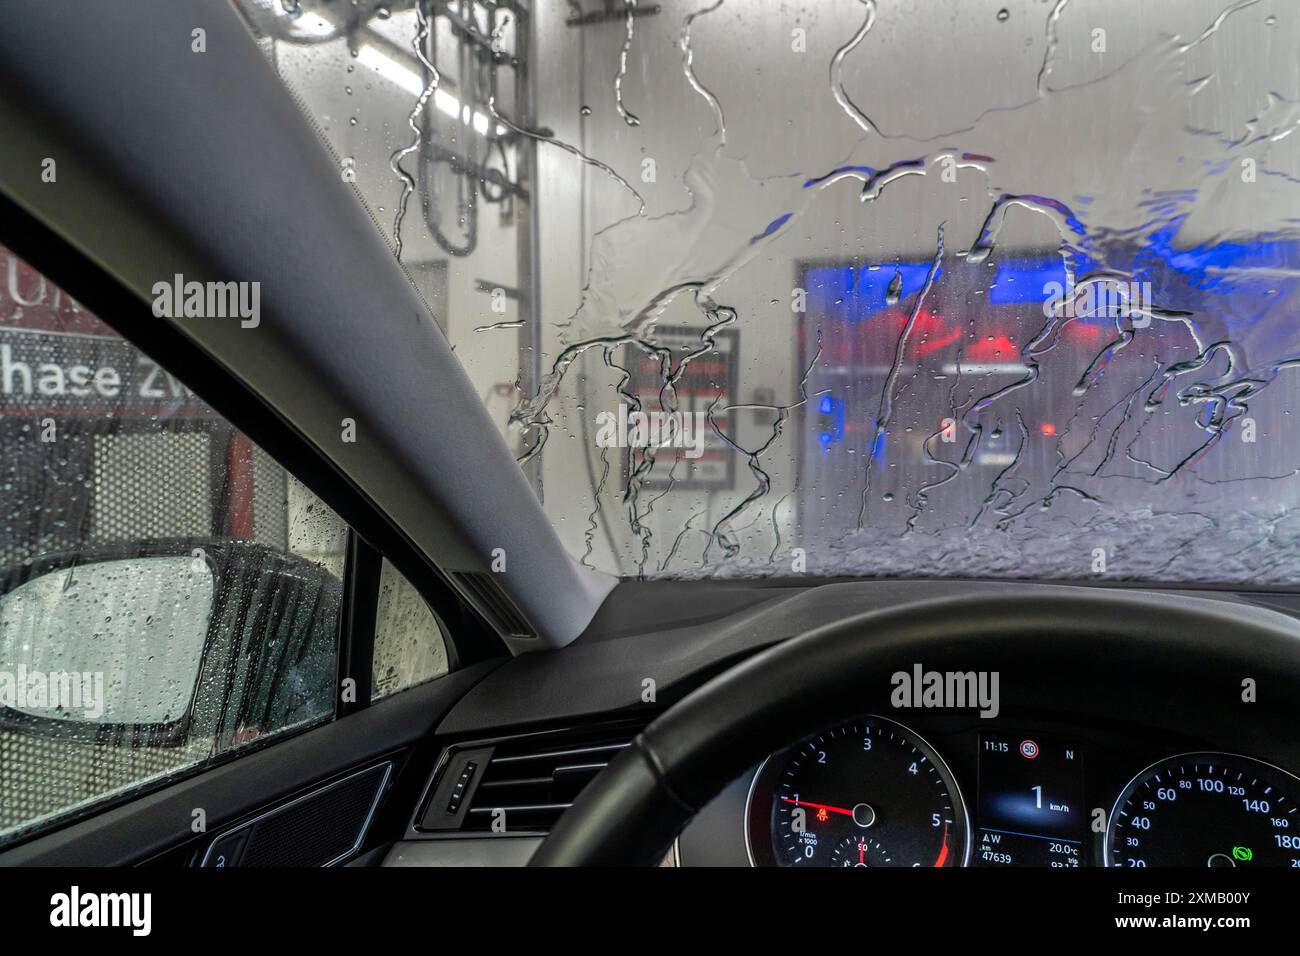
[460,722,645,832]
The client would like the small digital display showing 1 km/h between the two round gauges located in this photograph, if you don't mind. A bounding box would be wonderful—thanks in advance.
[972,734,1087,866]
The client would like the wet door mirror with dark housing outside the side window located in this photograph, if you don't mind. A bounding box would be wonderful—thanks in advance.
[0,541,342,752]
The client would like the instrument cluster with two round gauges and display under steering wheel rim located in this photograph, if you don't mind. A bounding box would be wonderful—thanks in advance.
[676,713,1300,868]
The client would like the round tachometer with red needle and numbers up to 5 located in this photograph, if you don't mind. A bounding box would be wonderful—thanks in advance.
[748,717,970,866]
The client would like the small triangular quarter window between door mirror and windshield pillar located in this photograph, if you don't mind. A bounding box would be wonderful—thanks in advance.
[371,558,447,701]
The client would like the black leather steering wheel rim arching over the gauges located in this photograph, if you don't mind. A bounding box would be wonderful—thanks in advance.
[530,585,1300,866]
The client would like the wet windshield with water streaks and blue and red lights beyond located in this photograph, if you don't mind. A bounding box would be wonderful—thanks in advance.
[242,0,1300,587]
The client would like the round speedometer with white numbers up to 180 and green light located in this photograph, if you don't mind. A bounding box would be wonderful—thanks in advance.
[1105,753,1300,866]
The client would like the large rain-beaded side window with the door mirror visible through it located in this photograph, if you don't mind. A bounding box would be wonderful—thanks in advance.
[0,247,353,844]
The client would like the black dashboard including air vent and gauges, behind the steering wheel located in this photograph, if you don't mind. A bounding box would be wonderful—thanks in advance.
[386,581,1300,869]
